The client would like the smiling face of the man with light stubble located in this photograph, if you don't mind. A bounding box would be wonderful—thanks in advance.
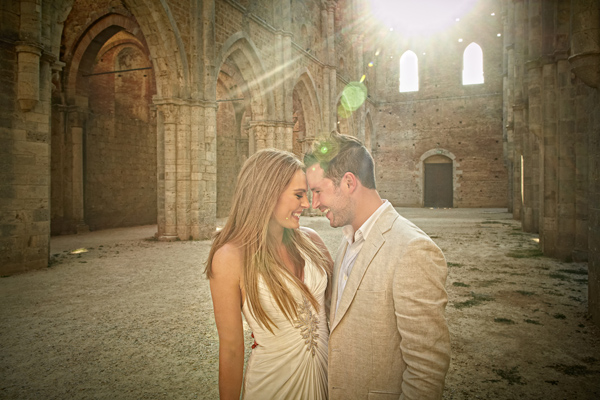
[306,163,354,228]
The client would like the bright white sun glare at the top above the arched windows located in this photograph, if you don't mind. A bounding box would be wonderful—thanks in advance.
[370,0,477,36]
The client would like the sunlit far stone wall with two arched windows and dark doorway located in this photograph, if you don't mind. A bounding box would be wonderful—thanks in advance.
[364,2,507,207]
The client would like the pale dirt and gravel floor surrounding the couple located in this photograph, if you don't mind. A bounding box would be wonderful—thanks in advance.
[0,208,600,400]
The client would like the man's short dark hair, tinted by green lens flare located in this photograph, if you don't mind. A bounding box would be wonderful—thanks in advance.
[304,131,376,189]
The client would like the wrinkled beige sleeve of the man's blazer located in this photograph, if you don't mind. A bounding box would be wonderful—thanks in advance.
[393,236,450,400]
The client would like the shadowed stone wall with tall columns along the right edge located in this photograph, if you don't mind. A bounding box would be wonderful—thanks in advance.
[504,0,600,322]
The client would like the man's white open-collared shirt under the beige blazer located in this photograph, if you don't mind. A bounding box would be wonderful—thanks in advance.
[335,200,390,312]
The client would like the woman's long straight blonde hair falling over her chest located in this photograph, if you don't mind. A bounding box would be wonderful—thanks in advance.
[205,149,331,332]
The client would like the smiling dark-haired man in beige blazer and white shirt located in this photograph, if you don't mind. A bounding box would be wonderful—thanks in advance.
[304,132,450,400]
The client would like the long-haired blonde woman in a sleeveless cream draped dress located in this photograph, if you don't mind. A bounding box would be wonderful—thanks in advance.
[206,150,332,400]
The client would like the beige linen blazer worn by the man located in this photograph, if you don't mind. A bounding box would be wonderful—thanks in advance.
[329,204,450,400]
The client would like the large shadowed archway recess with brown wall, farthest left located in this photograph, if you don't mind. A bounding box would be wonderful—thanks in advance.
[51,9,157,234]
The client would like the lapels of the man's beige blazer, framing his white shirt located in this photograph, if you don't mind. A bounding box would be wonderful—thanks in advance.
[329,204,399,332]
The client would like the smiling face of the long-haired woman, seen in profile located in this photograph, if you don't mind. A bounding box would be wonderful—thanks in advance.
[269,170,309,229]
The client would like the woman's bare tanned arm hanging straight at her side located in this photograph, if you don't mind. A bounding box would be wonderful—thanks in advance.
[210,244,244,400]
